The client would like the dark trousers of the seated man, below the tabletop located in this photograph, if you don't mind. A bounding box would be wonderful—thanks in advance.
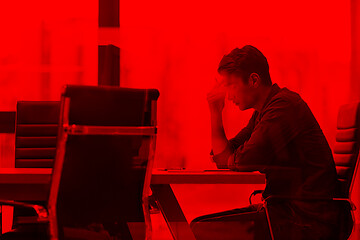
[190,204,347,240]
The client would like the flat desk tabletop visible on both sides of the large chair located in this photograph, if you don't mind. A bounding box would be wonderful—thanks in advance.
[0,168,265,184]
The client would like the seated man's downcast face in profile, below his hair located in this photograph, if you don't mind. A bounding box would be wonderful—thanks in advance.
[221,74,257,111]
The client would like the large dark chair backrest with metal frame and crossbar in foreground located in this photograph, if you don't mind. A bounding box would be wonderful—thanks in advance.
[48,86,159,239]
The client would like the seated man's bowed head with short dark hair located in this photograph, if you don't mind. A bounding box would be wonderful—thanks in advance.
[218,45,272,110]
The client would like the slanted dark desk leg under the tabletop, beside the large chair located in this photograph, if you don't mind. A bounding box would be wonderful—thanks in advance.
[151,184,196,240]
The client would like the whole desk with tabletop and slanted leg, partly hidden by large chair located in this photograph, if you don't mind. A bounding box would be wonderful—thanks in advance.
[0,168,265,240]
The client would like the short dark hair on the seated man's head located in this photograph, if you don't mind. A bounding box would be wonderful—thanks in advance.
[218,45,272,86]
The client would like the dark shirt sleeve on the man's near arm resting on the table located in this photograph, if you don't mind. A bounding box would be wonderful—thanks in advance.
[228,98,299,171]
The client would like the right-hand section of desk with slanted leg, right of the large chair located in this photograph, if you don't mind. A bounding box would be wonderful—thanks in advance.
[151,170,265,240]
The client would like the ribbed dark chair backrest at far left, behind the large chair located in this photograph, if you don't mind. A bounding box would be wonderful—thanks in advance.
[15,101,60,168]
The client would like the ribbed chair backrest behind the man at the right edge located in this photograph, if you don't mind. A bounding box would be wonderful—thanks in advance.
[334,102,360,198]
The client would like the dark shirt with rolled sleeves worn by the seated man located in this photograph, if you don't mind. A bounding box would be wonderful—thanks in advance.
[230,84,339,231]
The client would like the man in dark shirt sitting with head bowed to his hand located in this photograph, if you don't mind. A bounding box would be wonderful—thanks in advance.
[191,45,352,240]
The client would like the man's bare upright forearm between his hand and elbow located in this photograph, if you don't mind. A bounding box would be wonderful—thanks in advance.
[210,112,229,154]
